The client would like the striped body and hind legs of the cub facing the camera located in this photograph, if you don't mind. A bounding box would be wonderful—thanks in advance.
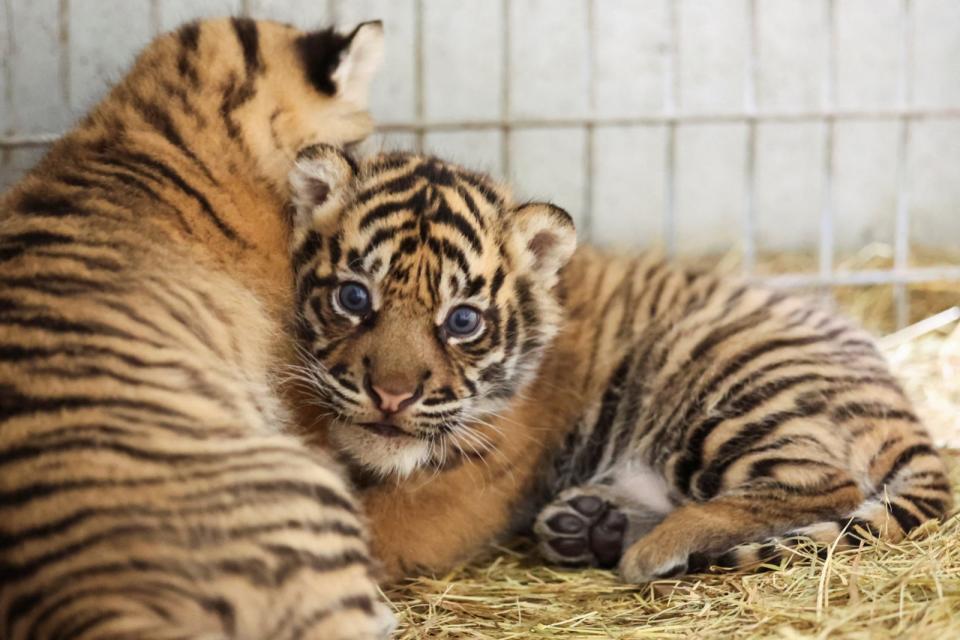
[535,250,951,581]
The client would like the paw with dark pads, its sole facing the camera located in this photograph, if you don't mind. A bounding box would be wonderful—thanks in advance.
[534,487,628,568]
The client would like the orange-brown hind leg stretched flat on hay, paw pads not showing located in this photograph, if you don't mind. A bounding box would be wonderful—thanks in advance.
[619,469,864,583]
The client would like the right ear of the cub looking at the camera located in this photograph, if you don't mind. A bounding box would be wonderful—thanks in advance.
[510,202,577,284]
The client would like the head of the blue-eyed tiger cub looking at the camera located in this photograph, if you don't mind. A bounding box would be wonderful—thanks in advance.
[291,145,576,476]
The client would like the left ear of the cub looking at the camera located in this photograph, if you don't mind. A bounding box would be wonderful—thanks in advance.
[290,144,357,229]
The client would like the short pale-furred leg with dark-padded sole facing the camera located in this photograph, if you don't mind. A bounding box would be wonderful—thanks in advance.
[533,483,664,568]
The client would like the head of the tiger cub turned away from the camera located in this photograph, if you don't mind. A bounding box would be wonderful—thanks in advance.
[111,17,383,188]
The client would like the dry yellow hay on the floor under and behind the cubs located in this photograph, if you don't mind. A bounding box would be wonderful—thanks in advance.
[387,244,960,640]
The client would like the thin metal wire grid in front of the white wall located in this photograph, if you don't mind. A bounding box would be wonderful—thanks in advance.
[0,0,960,327]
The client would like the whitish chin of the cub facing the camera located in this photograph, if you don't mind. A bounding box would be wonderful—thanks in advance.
[330,423,430,478]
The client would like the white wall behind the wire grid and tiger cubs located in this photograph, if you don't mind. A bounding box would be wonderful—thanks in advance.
[0,0,960,253]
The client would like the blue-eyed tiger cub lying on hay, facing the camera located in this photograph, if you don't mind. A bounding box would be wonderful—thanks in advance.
[291,147,951,582]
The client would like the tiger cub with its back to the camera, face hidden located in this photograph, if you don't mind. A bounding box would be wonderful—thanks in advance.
[0,18,392,640]
